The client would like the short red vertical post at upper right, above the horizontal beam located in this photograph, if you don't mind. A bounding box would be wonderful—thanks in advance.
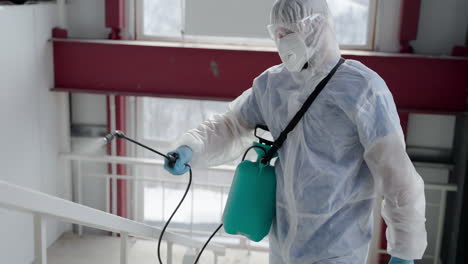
[400,0,421,53]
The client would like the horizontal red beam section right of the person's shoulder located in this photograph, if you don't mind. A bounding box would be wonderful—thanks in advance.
[347,55,468,111]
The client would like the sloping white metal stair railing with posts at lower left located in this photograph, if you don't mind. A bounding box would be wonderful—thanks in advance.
[0,181,225,264]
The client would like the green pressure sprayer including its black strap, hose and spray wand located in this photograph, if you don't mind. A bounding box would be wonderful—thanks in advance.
[104,59,344,264]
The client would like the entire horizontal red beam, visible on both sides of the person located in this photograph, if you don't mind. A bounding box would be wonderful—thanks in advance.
[54,40,468,111]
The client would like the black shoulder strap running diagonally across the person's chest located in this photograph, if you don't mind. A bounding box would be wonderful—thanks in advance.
[261,58,345,164]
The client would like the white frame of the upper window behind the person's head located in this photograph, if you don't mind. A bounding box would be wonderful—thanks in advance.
[134,0,379,51]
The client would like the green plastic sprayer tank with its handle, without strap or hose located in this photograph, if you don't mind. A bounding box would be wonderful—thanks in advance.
[223,129,276,242]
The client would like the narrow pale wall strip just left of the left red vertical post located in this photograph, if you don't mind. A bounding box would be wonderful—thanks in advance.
[67,0,110,229]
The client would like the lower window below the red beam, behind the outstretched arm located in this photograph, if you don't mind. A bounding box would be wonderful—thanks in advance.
[136,97,267,248]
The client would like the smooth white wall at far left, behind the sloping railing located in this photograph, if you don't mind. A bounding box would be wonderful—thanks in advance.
[0,4,70,264]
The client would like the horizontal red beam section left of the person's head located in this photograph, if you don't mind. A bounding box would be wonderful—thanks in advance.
[54,41,280,100]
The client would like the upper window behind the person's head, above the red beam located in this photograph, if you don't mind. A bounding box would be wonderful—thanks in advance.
[136,0,377,49]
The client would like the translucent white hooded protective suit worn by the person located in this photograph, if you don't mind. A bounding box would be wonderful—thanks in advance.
[178,0,427,264]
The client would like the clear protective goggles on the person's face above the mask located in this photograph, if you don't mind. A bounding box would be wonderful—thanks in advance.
[267,14,325,41]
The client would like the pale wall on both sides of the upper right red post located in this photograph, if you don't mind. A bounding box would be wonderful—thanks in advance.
[375,0,468,55]
